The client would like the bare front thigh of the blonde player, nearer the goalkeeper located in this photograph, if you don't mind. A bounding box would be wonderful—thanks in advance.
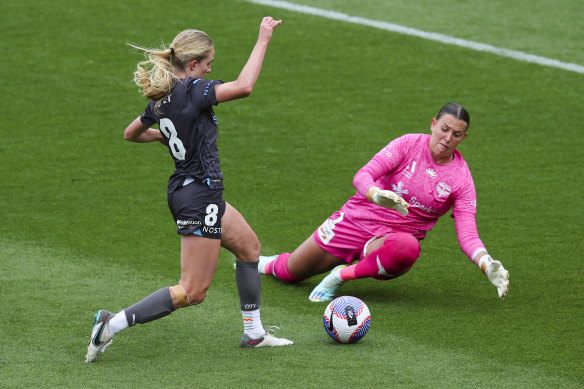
[221,203,261,262]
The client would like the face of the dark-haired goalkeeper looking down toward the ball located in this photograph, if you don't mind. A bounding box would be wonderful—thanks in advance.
[430,115,468,163]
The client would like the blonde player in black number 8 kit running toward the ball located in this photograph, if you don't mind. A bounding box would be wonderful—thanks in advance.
[86,17,292,362]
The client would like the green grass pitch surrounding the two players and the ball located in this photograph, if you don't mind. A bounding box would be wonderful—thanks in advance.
[0,0,584,388]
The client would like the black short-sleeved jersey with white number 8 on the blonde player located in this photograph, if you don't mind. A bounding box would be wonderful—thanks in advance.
[140,77,223,193]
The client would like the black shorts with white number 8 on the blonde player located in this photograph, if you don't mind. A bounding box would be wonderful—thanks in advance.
[168,181,225,239]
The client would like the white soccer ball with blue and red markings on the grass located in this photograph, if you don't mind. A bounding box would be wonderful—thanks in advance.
[323,296,371,343]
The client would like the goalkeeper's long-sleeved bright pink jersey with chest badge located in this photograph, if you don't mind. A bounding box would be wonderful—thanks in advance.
[341,134,484,260]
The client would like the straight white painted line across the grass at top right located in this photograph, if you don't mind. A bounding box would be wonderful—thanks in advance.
[245,0,584,74]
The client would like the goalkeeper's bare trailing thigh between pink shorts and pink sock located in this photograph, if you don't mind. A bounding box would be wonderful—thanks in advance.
[288,235,345,278]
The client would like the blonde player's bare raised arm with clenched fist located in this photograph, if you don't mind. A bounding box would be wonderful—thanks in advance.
[215,16,282,103]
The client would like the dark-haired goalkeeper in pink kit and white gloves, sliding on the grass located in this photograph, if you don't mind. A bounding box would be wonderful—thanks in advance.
[258,103,509,302]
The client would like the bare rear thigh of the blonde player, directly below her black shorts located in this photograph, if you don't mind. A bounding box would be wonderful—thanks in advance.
[180,234,221,304]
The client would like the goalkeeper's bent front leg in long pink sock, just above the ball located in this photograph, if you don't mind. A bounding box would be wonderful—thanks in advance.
[339,232,420,281]
